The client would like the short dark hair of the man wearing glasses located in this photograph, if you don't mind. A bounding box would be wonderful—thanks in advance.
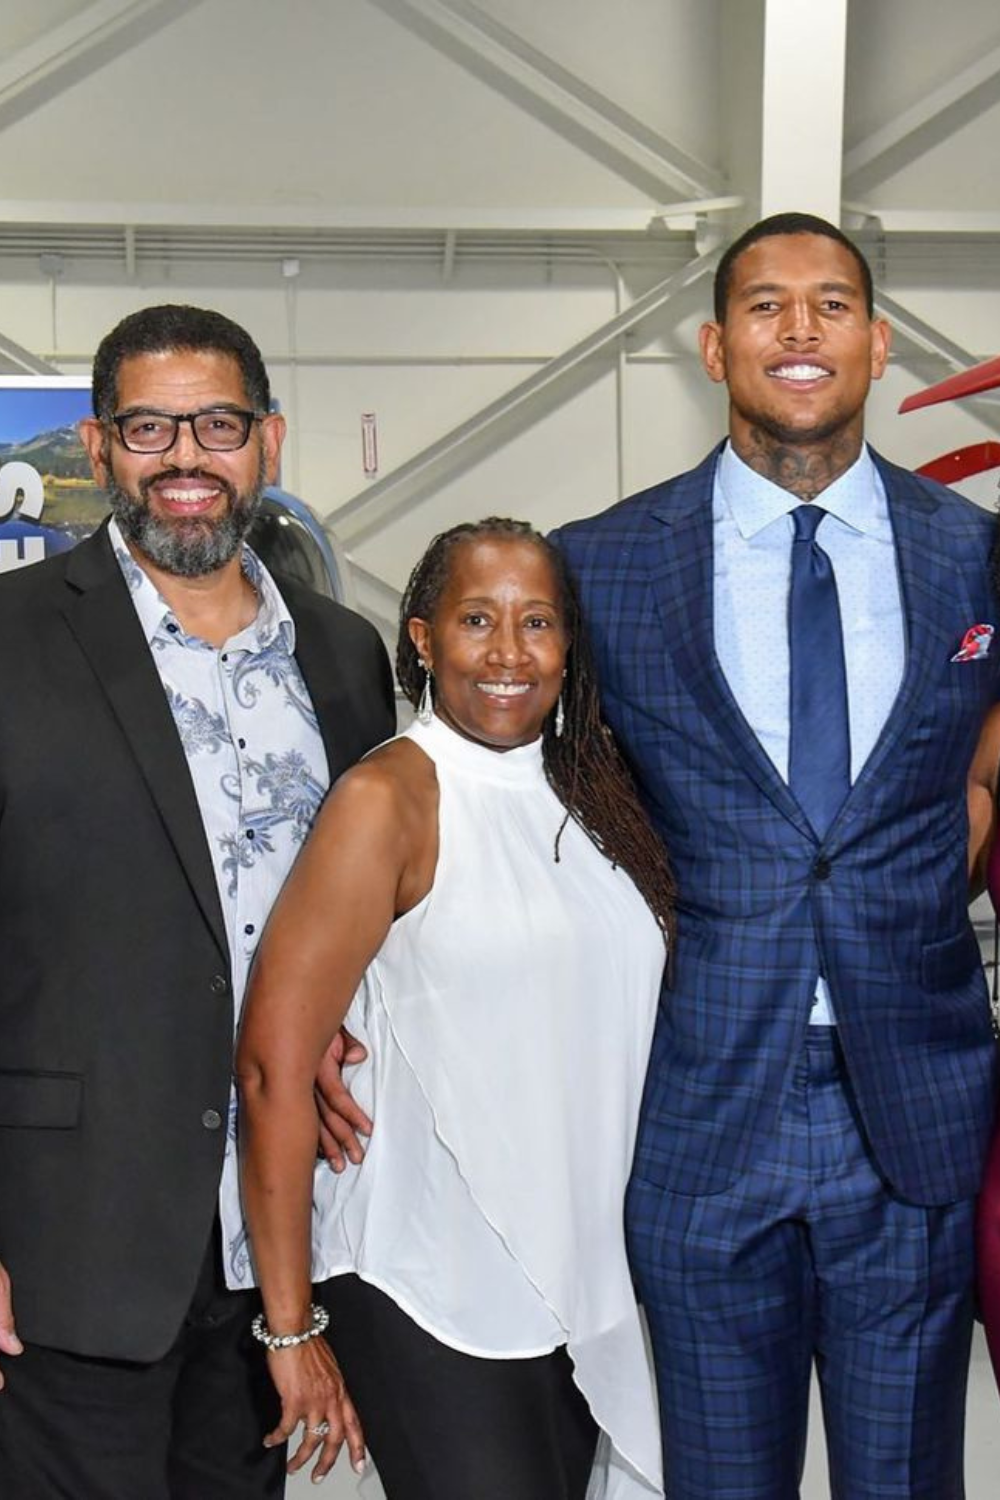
[91,303,271,422]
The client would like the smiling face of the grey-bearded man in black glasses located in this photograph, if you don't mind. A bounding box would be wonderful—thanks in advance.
[79,350,285,578]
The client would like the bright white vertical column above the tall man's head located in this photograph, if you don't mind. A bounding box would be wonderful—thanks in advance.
[760,0,847,224]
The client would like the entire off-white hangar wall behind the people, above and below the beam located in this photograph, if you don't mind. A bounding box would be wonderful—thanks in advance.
[0,0,1000,627]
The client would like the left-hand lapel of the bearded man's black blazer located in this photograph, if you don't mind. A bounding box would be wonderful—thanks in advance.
[64,525,229,963]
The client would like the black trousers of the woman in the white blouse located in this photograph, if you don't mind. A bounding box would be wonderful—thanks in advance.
[319,1277,597,1500]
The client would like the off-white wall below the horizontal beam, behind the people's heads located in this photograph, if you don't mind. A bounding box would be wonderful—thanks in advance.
[0,249,1000,612]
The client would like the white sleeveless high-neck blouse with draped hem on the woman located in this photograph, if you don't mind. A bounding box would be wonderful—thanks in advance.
[305,717,664,1500]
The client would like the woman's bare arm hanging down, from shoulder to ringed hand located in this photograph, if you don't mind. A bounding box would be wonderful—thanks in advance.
[237,743,436,1476]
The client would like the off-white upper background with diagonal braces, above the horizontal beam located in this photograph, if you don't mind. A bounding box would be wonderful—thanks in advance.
[0,0,1000,230]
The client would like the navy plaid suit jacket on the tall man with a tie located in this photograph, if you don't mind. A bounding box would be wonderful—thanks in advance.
[555,450,1000,1203]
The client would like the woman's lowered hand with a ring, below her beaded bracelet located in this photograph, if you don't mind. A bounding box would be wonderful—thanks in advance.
[264,1338,364,1484]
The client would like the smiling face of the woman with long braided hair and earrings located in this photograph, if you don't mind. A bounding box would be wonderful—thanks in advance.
[408,537,568,750]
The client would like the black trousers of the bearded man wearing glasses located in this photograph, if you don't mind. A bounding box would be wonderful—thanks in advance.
[0,1226,285,1500]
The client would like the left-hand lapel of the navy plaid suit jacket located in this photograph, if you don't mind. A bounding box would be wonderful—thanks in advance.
[651,449,816,839]
